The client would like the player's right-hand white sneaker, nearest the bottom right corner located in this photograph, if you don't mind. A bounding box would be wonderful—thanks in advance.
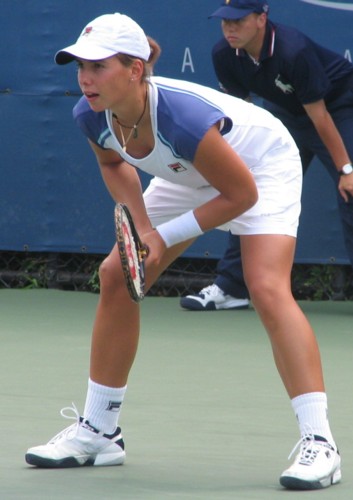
[279,434,341,490]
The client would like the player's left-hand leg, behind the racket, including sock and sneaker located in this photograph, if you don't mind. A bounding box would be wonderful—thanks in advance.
[26,227,190,468]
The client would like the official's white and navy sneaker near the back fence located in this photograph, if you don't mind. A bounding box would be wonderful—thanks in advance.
[180,284,249,311]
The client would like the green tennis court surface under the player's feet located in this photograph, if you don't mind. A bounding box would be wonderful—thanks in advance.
[0,290,353,500]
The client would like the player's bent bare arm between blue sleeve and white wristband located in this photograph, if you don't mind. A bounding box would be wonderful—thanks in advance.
[193,125,257,231]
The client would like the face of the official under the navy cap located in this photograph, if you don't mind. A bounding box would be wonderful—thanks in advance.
[222,14,266,53]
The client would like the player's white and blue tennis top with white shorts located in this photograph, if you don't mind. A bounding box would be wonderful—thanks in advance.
[74,77,302,236]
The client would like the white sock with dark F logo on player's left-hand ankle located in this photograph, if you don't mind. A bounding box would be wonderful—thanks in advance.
[83,379,126,434]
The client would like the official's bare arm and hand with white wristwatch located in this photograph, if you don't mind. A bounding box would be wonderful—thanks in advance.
[304,100,353,201]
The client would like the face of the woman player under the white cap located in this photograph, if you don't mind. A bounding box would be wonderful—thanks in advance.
[77,56,131,112]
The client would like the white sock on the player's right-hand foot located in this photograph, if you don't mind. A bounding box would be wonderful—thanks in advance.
[292,392,335,444]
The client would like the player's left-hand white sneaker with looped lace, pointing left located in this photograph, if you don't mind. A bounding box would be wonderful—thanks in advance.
[25,405,125,468]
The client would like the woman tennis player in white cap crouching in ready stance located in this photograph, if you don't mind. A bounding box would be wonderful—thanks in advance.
[26,13,341,489]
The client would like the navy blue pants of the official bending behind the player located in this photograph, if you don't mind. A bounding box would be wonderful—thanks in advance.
[215,89,353,298]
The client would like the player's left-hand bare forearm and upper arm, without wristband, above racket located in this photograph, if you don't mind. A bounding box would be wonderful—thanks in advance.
[88,141,151,234]
